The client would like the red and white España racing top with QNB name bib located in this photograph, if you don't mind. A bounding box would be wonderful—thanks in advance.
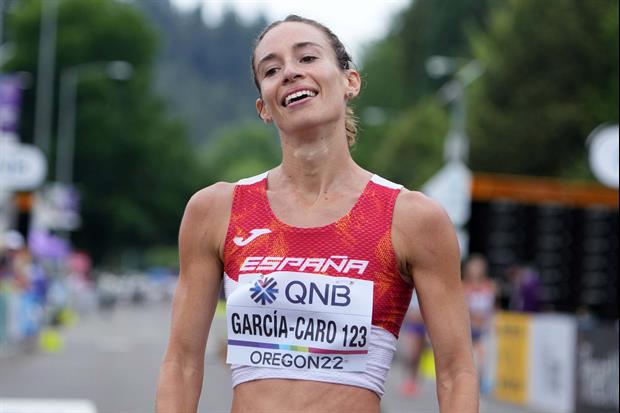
[224,173,412,386]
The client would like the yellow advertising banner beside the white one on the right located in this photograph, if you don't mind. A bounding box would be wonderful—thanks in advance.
[495,313,530,404]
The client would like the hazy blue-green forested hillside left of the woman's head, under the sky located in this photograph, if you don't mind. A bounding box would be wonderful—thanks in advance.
[135,0,266,146]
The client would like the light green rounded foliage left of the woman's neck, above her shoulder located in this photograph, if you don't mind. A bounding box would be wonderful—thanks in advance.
[201,121,281,182]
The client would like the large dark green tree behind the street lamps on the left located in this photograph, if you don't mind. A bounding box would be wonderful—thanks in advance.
[7,0,201,262]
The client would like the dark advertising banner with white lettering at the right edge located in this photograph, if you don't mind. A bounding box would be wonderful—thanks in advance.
[576,322,619,413]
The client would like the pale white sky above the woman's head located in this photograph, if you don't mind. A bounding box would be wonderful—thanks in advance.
[172,0,410,62]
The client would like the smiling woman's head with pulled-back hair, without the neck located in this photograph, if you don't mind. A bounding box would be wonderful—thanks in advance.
[254,22,360,133]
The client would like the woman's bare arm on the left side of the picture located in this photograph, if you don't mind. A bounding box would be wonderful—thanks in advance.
[155,184,232,413]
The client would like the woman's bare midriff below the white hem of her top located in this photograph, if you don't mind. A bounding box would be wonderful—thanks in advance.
[231,379,380,413]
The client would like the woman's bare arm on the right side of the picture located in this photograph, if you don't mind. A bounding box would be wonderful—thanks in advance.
[393,192,479,413]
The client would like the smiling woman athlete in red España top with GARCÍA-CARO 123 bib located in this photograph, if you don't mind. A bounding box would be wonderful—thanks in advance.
[156,16,479,413]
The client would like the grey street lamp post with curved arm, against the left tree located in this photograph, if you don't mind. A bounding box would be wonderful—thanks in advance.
[55,61,133,184]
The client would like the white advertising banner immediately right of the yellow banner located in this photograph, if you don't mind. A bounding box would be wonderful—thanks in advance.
[528,315,577,413]
